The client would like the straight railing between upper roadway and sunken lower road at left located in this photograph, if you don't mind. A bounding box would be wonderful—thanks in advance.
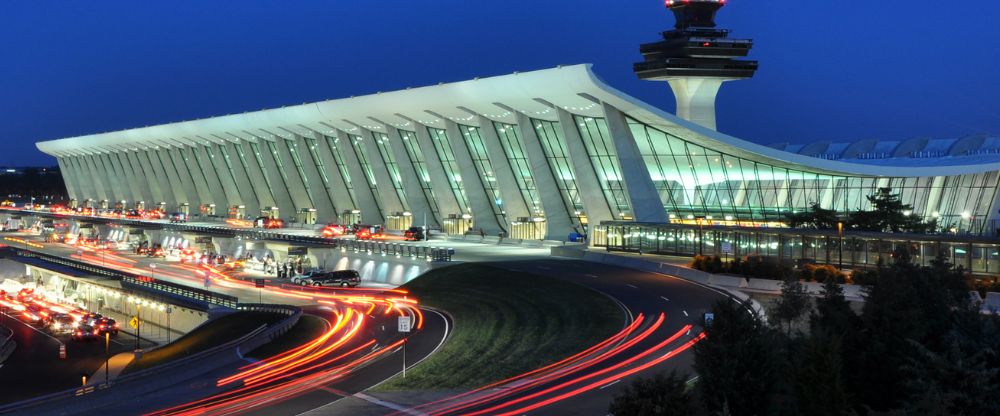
[7,248,239,308]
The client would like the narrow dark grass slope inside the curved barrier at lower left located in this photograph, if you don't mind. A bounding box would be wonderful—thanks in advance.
[122,312,286,374]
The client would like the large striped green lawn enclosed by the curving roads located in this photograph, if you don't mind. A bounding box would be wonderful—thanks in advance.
[377,264,624,391]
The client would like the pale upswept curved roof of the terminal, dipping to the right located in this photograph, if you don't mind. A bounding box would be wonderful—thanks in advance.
[37,64,1000,176]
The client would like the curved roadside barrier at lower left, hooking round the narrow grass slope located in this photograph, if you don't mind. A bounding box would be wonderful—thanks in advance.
[0,304,302,415]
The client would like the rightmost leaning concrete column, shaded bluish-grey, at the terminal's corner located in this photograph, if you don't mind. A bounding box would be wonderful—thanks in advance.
[602,103,669,224]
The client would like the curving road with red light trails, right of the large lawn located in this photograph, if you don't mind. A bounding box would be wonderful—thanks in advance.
[388,259,725,415]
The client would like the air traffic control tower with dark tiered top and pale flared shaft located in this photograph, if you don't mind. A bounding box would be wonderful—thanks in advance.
[634,0,757,130]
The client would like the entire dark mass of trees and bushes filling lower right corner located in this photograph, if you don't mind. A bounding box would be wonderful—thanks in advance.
[609,250,1000,416]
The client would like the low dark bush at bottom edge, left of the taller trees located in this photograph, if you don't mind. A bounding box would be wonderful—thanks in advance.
[608,371,695,416]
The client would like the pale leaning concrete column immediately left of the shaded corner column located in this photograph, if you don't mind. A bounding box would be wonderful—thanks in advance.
[555,108,615,225]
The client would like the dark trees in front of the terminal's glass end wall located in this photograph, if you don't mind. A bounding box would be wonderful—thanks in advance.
[785,188,938,234]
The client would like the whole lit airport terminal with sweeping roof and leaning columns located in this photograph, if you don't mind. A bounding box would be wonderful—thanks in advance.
[38,65,1000,240]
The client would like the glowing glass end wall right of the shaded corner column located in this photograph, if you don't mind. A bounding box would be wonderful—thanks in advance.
[628,119,998,231]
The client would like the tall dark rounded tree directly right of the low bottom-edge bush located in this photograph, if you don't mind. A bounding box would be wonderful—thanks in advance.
[694,299,778,416]
